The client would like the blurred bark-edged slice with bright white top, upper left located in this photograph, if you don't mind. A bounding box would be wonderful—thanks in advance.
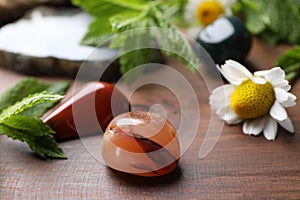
[0,7,163,81]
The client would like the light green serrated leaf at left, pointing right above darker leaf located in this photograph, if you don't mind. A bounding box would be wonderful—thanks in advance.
[0,92,63,123]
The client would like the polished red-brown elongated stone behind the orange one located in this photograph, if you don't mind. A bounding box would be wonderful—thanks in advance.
[42,82,130,140]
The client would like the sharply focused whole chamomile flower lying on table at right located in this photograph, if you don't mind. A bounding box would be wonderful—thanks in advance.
[209,60,296,140]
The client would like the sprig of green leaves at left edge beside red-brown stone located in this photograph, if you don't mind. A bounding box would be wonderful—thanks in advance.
[0,78,69,158]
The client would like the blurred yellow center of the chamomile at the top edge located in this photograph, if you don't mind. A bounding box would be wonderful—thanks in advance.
[197,0,224,26]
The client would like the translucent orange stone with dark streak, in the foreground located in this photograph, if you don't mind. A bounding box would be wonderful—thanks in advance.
[102,112,180,176]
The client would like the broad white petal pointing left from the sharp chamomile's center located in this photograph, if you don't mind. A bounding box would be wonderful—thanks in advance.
[209,84,235,110]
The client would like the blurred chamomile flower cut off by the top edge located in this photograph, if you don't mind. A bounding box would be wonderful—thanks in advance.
[184,0,236,35]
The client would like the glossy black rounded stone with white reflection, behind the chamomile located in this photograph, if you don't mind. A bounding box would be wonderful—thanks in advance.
[196,16,252,64]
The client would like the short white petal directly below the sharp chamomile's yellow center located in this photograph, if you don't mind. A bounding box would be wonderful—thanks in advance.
[243,117,266,135]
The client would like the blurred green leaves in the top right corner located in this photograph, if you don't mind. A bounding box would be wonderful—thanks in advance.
[233,0,300,45]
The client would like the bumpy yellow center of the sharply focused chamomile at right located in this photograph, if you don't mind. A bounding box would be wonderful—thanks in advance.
[230,79,275,119]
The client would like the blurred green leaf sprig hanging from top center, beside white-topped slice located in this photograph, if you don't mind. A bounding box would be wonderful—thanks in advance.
[72,0,199,81]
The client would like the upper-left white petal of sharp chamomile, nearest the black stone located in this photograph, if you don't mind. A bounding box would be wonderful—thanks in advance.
[217,60,252,85]
